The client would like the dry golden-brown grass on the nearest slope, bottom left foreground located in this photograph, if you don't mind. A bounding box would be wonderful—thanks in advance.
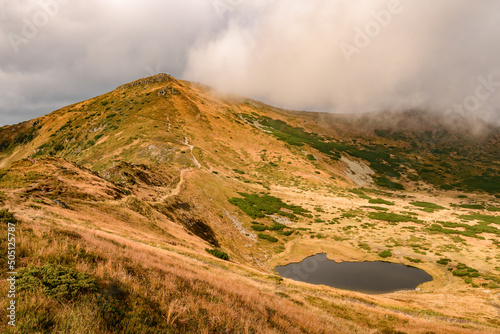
[1,210,362,333]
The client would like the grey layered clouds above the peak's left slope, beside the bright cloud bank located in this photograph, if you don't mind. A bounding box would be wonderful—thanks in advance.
[0,0,215,125]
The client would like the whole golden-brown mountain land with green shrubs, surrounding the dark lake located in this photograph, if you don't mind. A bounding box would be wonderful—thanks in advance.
[0,74,500,333]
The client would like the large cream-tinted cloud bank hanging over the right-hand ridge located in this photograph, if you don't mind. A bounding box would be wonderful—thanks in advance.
[184,0,500,123]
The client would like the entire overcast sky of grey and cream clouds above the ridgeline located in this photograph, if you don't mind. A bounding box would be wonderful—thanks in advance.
[0,0,500,125]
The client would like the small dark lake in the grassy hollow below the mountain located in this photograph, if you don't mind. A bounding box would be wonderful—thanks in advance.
[275,253,432,294]
